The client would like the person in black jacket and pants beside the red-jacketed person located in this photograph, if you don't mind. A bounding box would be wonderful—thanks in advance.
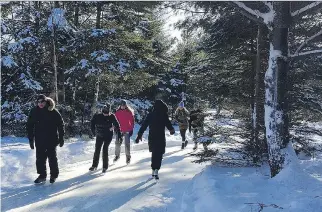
[89,104,121,173]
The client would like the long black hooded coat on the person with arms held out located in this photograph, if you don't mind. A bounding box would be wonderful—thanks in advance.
[138,100,174,154]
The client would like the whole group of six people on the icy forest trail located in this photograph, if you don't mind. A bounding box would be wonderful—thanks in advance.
[27,94,204,184]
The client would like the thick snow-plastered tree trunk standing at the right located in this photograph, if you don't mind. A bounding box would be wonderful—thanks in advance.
[265,2,291,177]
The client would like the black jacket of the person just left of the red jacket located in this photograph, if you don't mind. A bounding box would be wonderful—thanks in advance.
[91,113,121,139]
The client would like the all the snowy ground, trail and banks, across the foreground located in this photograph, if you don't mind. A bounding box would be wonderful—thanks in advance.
[1,122,322,212]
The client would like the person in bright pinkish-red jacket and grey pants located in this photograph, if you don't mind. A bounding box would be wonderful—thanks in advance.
[114,100,134,164]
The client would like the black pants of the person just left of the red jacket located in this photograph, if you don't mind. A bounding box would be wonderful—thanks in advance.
[92,136,112,169]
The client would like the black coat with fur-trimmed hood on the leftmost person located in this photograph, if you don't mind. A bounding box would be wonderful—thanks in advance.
[27,97,65,148]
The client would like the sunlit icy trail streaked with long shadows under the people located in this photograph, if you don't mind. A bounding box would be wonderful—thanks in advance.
[1,141,205,212]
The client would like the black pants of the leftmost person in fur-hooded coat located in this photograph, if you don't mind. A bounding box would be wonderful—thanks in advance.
[36,147,59,178]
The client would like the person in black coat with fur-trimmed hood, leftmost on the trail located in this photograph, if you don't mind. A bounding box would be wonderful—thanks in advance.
[27,94,65,184]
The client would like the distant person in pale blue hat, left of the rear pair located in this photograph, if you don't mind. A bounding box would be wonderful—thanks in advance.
[175,101,189,149]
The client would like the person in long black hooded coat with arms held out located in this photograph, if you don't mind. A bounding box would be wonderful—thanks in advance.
[135,100,175,179]
